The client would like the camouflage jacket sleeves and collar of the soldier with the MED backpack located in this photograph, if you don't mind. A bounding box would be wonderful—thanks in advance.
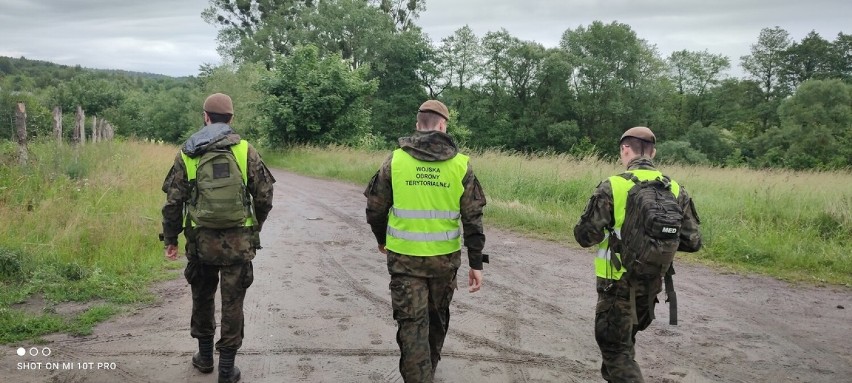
[574,157,701,252]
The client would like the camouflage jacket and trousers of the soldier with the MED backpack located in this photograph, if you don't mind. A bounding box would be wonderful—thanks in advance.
[574,157,701,382]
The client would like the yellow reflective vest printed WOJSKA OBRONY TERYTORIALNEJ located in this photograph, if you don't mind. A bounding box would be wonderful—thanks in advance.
[385,149,468,257]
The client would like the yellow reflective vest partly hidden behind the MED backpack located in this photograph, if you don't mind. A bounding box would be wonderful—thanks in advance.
[595,169,680,280]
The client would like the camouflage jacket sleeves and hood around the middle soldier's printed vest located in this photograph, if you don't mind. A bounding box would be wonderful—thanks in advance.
[364,131,487,270]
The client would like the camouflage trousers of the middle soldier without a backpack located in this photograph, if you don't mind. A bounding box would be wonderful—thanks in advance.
[388,251,461,383]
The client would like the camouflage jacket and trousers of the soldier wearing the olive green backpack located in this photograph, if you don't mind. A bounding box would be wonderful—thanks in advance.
[163,124,275,351]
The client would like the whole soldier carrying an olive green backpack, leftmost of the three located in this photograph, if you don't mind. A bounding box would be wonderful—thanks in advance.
[162,93,275,383]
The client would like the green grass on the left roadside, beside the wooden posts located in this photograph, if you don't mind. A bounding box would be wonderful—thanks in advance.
[0,141,177,343]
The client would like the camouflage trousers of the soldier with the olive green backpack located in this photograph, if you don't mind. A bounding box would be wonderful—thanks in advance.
[184,261,254,351]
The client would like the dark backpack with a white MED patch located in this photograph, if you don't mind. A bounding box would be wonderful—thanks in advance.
[620,172,683,281]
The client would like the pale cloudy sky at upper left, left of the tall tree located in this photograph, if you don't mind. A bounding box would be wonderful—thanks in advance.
[0,0,220,76]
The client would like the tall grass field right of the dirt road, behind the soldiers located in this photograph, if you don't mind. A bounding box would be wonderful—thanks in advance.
[264,147,852,286]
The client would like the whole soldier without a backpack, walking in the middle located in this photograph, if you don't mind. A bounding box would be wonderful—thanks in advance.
[364,100,488,383]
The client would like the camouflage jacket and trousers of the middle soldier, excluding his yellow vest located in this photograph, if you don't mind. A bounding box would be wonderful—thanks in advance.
[364,131,488,382]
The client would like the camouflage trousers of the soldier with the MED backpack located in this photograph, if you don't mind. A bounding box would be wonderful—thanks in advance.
[595,278,661,383]
